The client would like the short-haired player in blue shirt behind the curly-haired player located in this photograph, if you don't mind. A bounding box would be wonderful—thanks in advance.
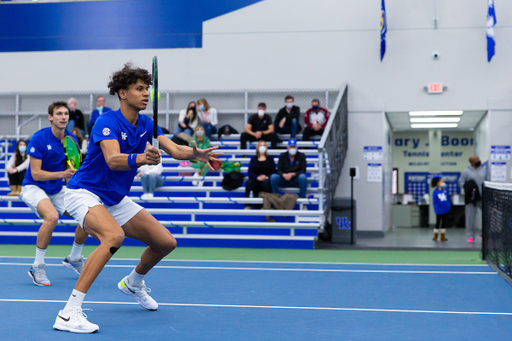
[20,102,88,286]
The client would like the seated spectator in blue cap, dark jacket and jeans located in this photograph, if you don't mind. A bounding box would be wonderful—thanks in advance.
[270,139,308,198]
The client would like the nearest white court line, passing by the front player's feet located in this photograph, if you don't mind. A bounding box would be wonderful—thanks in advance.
[0,298,512,316]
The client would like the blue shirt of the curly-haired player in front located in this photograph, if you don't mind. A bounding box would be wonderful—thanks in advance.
[68,109,163,206]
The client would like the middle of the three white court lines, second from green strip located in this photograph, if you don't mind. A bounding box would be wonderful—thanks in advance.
[0,263,498,275]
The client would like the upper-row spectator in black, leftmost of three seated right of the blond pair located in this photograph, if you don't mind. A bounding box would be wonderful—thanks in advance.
[240,103,277,149]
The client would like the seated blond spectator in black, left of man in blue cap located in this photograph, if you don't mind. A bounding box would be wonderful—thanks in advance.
[245,140,276,209]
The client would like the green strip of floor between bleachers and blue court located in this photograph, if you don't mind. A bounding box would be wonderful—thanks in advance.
[0,244,487,265]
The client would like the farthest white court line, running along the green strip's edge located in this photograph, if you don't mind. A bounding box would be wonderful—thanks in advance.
[0,256,489,267]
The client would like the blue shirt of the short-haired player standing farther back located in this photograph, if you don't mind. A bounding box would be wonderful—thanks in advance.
[23,127,78,194]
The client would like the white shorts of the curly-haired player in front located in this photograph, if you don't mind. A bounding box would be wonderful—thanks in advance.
[64,188,142,228]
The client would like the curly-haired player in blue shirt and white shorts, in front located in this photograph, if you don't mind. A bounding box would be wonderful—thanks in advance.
[53,64,221,333]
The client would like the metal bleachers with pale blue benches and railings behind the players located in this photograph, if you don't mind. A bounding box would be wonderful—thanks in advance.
[0,85,347,243]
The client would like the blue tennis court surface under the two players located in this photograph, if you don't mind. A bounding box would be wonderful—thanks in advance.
[0,257,512,341]
